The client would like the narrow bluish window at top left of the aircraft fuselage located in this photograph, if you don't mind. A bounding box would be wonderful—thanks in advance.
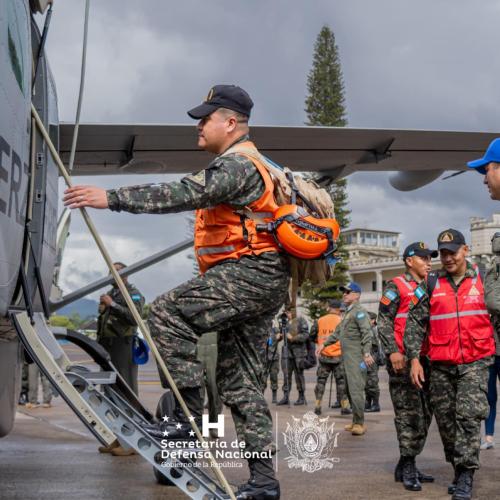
[7,2,29,95]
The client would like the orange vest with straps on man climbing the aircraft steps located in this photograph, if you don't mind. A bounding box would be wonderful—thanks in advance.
[194,141,279,274]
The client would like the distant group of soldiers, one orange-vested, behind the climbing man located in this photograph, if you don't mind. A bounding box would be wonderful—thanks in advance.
[265,283,384,435]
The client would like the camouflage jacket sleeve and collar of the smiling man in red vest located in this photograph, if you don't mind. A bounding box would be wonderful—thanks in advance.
[403,262,476,359]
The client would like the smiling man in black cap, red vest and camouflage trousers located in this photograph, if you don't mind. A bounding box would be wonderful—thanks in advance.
[403,229,495,500]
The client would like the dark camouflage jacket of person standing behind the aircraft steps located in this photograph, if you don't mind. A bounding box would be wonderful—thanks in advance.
[97,283,145,340]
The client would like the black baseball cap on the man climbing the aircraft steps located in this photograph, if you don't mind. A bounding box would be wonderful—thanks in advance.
[188,85,253,120]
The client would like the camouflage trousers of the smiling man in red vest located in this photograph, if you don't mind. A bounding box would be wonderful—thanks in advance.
[430,357,491,469]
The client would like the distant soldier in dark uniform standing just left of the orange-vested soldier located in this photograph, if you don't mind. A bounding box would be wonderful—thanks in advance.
[278,309,309,406]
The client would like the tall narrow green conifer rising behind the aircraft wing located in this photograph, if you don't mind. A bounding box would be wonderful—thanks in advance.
[302,26,350,318]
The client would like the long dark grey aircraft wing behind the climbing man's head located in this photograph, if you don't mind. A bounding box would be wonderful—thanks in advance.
[60,123,498,189]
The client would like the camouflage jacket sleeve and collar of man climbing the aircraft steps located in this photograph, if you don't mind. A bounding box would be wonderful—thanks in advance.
[107,135,265,214]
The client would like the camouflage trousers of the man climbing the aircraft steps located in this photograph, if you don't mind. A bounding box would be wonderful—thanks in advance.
[148,253,289,451]
